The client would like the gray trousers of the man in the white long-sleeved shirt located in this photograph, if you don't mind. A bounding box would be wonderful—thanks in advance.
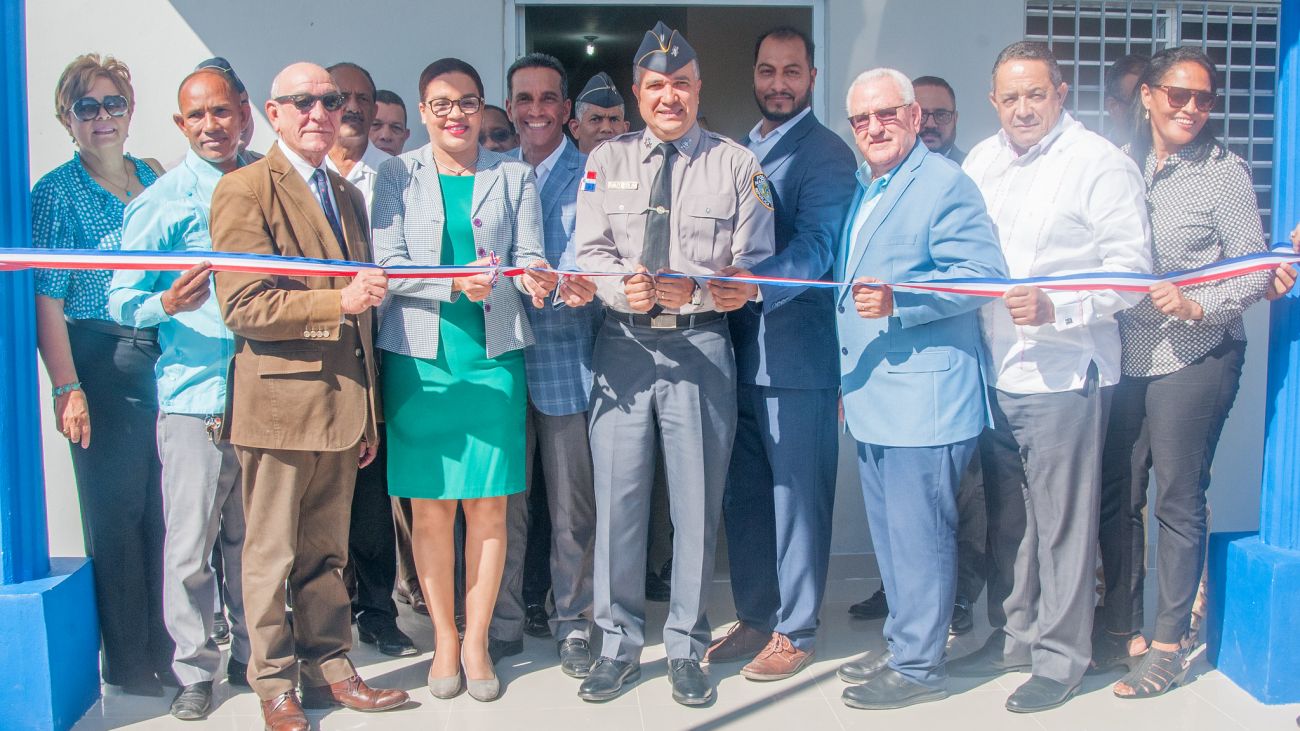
[980,369,1114,685]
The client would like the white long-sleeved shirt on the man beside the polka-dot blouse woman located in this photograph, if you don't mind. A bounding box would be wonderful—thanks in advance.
[962,113,1152,394]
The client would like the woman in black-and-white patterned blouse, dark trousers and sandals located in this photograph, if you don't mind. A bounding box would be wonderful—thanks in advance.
[1093,48,1269,698]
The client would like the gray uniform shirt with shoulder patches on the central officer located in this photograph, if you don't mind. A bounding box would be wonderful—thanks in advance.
[573,125,775,313]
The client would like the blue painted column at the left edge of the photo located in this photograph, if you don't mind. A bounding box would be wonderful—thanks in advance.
[0,1,99,730]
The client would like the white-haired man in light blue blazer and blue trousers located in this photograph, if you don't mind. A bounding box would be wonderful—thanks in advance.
[836,69,1006,709]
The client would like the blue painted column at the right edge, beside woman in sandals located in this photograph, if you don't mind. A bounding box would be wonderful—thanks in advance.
[1206,0,1300,704]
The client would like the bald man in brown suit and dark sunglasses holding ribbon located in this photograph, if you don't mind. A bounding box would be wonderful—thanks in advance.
[212,64,408,731]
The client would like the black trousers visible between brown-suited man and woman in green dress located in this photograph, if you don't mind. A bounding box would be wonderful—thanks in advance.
[347,424,398,627]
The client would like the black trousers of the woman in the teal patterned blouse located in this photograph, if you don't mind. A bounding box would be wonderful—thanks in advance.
[68,321,173,685]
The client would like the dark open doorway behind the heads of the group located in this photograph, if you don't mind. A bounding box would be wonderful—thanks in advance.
[520,3,820,140]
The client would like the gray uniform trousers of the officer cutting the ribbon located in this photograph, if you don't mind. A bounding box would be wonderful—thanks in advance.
[590,317,736,662]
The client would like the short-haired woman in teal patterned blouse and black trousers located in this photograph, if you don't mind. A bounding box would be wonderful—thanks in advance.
[31,53,174,696]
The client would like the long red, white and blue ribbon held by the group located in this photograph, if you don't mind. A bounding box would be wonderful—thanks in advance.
[0,245,1300,297]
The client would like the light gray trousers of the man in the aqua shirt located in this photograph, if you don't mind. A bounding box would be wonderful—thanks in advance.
[159,412,248,685]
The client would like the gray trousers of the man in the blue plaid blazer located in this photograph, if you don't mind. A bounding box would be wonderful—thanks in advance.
[490,401,595,640]
